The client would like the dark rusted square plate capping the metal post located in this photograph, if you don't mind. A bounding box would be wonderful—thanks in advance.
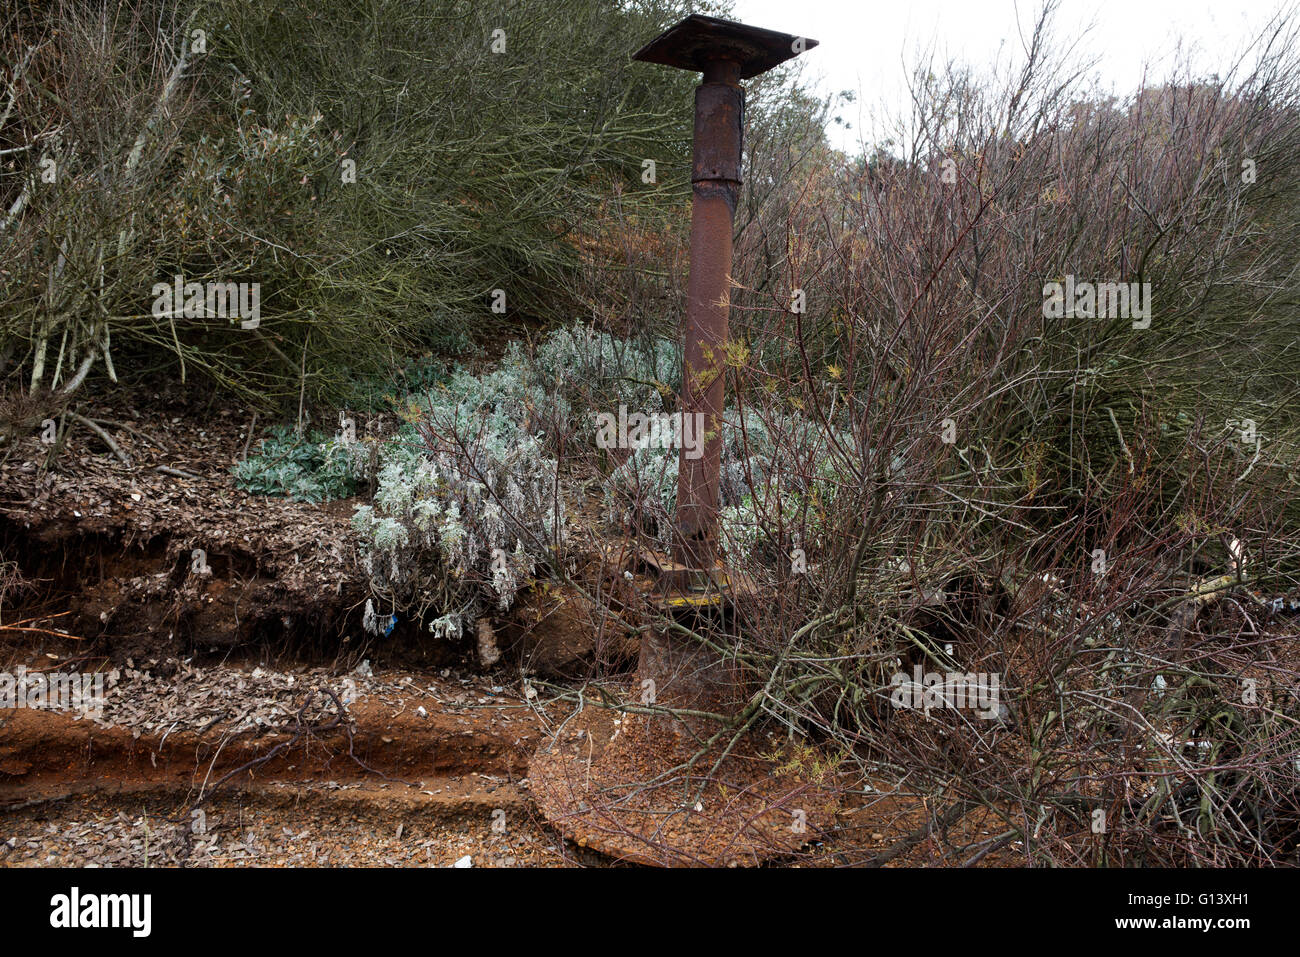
[632,13,816,79]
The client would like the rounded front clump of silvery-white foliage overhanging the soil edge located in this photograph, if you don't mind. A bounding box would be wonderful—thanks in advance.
[352,347,564,637]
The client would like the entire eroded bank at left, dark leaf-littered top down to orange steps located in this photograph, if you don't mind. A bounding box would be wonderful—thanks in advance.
[0,395,600,866]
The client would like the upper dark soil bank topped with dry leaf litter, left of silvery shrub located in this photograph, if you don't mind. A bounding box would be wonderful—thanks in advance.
[0,397,423,664]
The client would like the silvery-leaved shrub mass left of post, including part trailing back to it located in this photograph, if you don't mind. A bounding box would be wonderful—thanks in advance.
[354,326,680,637]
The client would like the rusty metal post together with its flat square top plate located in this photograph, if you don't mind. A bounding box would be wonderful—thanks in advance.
[633,14,816,570]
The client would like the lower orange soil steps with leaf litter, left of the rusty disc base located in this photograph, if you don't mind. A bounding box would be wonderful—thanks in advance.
[0,657,577,866]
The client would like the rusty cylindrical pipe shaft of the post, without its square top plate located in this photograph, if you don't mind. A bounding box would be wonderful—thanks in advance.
[675,60,745,568]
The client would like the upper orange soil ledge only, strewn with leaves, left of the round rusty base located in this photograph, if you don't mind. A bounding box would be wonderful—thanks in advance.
[0,660,541,780]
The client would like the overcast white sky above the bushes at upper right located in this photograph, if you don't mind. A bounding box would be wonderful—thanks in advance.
[735,0,1284,152]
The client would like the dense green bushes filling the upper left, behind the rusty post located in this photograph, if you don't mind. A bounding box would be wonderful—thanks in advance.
[0,0,722,402]
